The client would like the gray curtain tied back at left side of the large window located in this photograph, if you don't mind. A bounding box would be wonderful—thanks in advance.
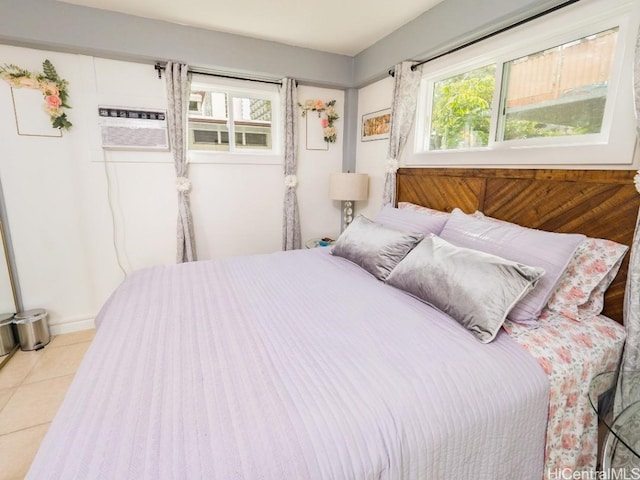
[382,62,421,205]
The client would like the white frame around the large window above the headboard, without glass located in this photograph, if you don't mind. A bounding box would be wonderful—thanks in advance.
[410,0,640,167]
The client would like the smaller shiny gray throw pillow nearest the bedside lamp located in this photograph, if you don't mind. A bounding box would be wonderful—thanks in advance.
[331,215,424,280]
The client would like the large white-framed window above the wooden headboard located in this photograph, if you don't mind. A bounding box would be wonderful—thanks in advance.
[407,0,638,164]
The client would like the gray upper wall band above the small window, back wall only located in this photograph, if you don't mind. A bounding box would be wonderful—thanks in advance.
[0,0,353,87]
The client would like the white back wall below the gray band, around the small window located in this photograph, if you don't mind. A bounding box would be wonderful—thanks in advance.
[0,45,344,333]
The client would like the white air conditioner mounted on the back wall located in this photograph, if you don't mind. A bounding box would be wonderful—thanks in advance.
[98,107,169,150]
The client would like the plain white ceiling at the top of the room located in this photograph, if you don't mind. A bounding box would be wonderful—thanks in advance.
[58,0,443,56]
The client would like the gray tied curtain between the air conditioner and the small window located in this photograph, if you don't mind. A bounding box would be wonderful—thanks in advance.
[165,62,196,263]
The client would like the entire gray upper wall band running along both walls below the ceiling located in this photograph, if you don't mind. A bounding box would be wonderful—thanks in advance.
[0,0,562,88]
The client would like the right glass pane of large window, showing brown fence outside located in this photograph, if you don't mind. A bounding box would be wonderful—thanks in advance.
[498,28,618,140]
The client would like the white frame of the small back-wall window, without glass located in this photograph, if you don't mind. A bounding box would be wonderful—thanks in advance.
[187,74,284,165]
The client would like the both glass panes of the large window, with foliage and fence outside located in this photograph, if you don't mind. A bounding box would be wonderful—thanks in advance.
[424,27,619,151]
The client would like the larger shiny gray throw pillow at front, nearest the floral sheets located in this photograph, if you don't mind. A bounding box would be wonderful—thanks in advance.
[386,234,544,343]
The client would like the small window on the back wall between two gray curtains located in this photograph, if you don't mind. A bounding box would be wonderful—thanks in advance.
[188,78,280,163]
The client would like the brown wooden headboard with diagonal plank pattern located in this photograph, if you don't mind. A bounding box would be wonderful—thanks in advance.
[396,168,640,323]
